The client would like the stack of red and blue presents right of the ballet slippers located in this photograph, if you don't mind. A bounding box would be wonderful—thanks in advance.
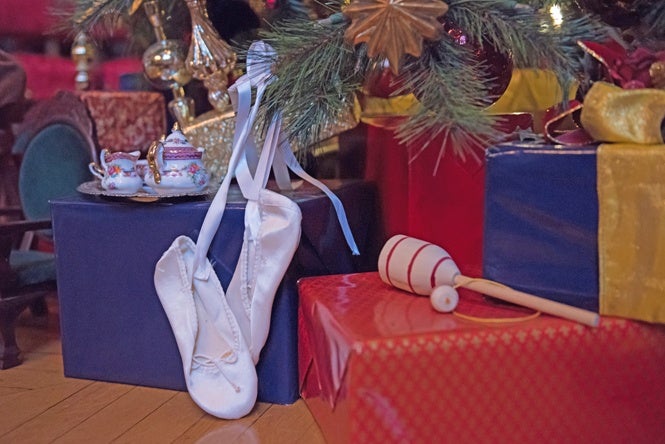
[299,71,665,443]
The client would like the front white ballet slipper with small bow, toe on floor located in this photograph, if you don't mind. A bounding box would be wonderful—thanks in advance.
[154,236,258,419]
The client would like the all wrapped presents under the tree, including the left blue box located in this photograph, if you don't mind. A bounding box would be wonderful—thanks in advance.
[53,45,665,443]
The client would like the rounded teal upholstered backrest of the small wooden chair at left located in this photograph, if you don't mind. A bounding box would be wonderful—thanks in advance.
[19,123,92,220]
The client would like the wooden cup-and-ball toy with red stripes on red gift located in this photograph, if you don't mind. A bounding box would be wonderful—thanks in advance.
[378,234,600,327]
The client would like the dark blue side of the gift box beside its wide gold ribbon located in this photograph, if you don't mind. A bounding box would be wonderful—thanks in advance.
[483,143,598,311]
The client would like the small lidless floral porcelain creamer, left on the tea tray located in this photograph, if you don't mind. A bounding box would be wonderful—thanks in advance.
[88,149,143,194]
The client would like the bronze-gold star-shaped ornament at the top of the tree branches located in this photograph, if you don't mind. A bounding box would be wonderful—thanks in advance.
[342,0,448,74]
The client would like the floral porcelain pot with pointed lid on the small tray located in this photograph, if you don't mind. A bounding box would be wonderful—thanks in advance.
[145,123,210,194]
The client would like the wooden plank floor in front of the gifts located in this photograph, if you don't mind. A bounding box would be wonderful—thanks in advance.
[0,298,324,444]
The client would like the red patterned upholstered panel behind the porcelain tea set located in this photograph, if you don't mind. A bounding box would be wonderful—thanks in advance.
[79,91,166,153]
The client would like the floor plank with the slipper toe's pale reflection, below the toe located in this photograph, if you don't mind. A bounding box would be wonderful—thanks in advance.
[174,402,271,444]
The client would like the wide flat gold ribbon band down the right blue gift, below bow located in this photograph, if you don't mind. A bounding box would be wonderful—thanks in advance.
[598,144,665,322]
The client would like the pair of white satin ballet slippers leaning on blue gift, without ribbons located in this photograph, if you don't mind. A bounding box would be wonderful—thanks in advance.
[155,190,301,419]
